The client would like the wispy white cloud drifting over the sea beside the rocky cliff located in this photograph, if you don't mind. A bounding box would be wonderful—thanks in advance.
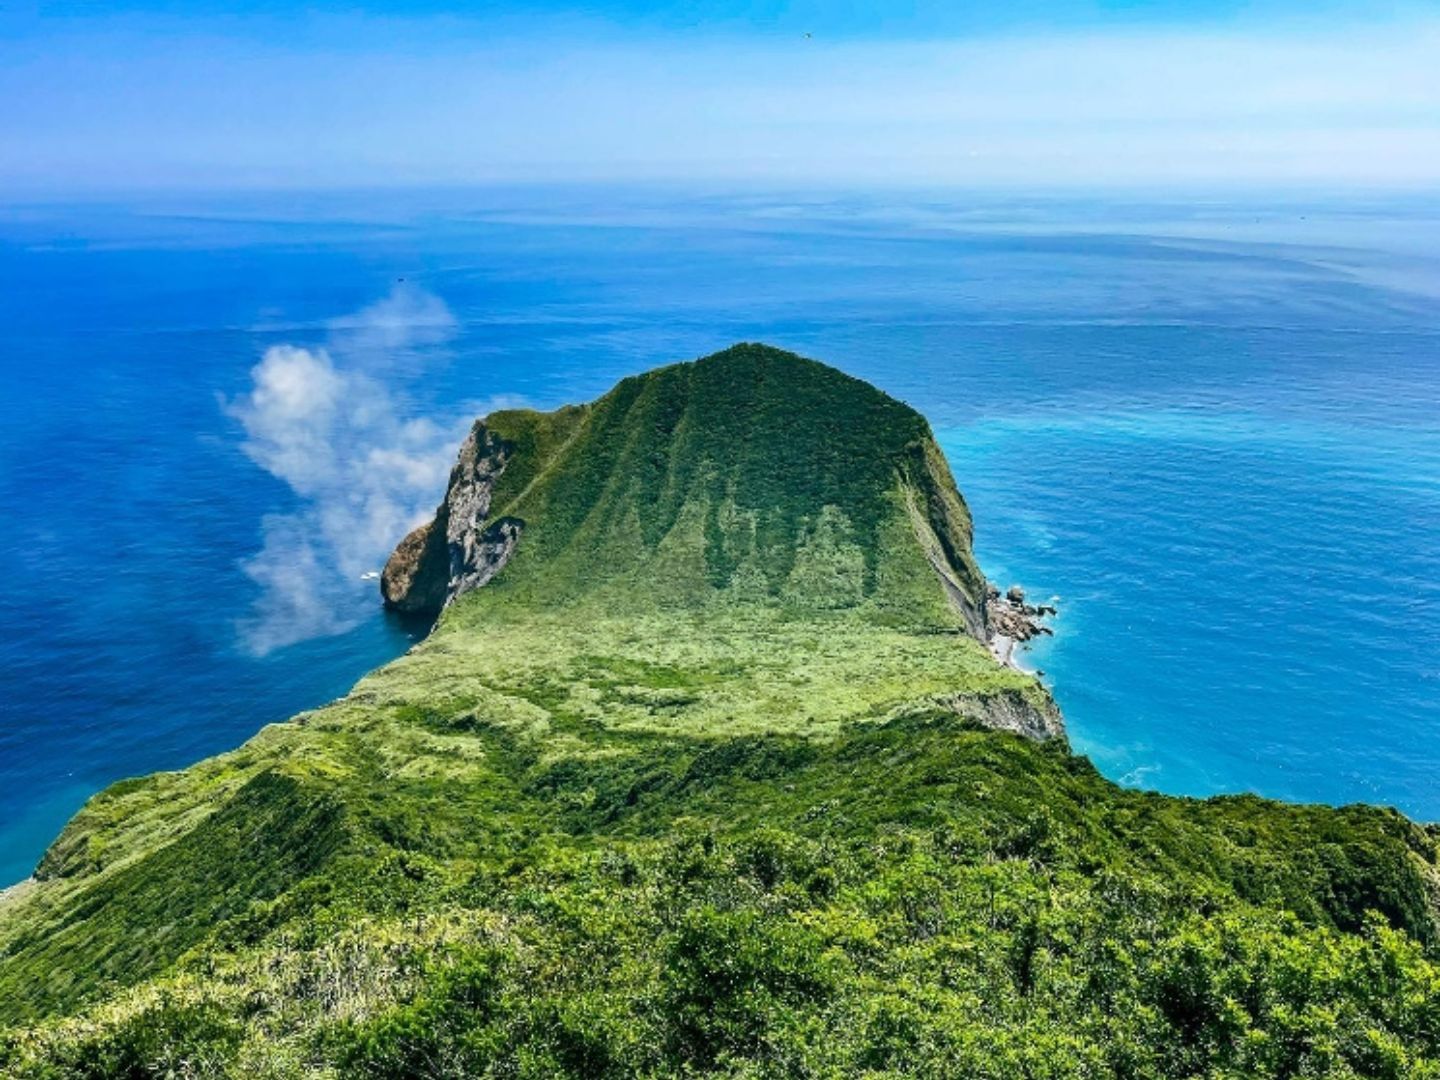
[225,287,474,655]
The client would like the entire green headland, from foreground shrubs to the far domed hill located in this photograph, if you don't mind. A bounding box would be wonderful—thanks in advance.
[0,346,1440,1077]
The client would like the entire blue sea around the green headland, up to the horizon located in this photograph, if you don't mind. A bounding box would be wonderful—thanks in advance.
[0,189,1440,884]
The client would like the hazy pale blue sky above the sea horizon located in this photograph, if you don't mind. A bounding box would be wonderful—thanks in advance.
[0,0,1440,196]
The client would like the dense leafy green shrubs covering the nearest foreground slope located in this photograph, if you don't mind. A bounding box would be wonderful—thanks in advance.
[0,714,1440,1077]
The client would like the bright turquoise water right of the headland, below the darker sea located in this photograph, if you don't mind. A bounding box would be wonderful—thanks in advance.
[943,394,1440,815]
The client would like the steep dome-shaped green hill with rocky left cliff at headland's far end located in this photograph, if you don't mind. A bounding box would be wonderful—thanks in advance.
[383,344,985,636]
